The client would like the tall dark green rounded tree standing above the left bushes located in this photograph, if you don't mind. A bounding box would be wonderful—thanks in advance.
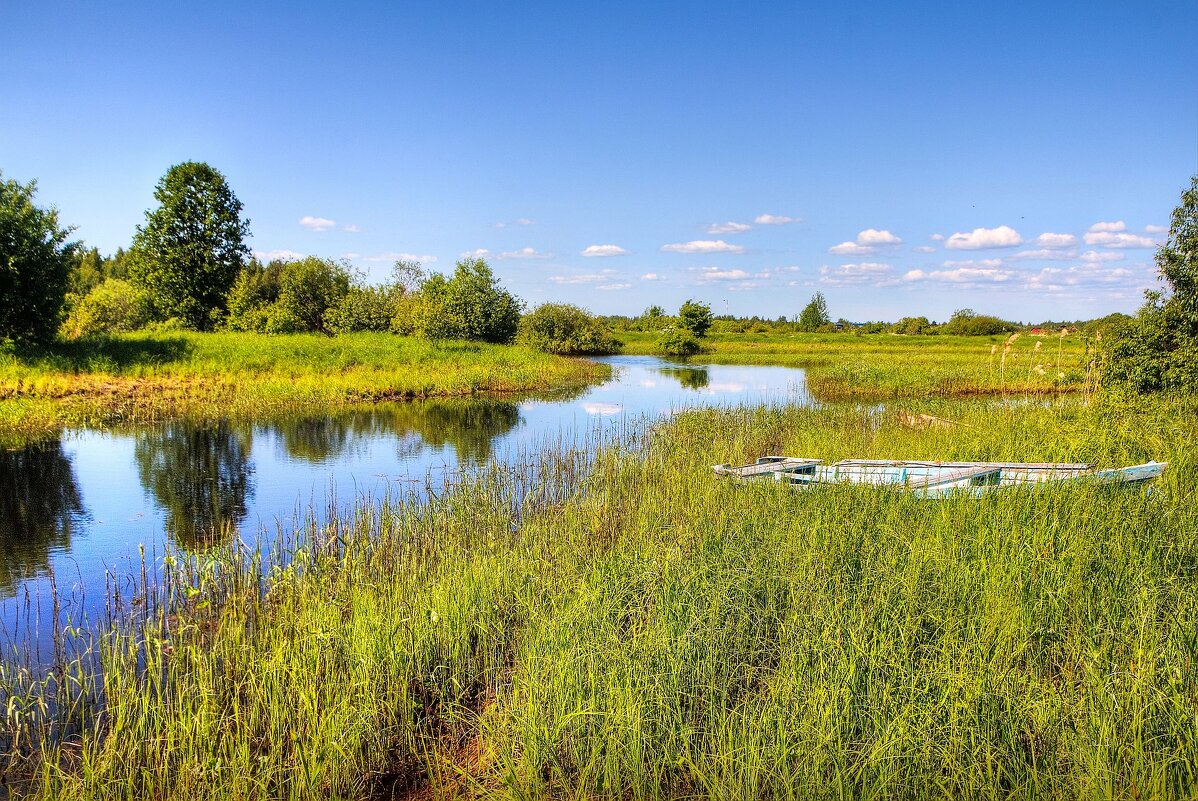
[129,162,249,330]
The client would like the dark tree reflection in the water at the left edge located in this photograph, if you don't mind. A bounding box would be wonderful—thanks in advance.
[0,442,84,597]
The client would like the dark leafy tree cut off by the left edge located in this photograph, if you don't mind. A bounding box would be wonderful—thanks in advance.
[0,172,79,341]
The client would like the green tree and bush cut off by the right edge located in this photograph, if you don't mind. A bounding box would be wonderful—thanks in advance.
[1105,176,1198,392]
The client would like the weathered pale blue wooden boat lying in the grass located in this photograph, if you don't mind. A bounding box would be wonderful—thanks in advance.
[713,456,1168,497]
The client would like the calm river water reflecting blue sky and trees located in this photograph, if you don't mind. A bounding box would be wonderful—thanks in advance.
[0,357,807,631]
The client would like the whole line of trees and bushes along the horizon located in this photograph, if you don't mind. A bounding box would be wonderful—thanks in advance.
[0,162,1198,390]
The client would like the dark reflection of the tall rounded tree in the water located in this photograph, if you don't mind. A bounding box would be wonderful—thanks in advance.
[134,421,253,551]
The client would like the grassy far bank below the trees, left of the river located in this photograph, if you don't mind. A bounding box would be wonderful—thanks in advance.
[0,333,607,445]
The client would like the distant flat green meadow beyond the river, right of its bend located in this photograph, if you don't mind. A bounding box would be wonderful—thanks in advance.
[621,332,1095,401]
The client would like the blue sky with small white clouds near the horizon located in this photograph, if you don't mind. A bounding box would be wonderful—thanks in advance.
[0,0,1198,321]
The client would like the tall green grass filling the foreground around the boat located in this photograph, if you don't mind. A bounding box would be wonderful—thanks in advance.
[6,390,1198,800]
